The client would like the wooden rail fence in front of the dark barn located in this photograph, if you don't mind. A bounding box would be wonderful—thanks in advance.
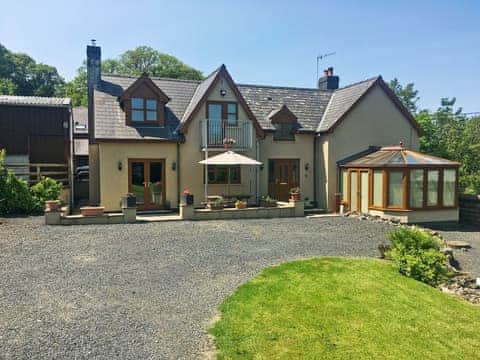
[5,163,69,185]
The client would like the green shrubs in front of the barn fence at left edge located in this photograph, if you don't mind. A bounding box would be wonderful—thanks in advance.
[0,150,62,215]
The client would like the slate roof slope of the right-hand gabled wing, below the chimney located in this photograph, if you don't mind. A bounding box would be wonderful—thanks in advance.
[316,76,380,132]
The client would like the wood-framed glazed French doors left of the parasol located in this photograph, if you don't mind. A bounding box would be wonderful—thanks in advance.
[128,159,166,210]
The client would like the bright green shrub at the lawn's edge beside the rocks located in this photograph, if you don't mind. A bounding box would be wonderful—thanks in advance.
[386,228,447,286]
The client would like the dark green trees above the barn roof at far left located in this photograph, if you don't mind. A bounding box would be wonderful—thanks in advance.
[0,44,64,96]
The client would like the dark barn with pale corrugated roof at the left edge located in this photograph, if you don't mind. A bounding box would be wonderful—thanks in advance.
[0,95,72,191]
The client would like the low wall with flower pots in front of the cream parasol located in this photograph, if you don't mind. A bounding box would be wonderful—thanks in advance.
[180,201,304,220]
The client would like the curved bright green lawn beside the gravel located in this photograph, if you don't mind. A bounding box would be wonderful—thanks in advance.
[211,258,480,359]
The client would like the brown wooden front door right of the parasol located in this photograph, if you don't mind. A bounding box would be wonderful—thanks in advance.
[269,159,300,201]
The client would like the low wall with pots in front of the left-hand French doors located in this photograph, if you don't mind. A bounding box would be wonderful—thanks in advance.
[45,208,137,225]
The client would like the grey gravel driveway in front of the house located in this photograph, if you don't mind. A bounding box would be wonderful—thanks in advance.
[0,217,474,359]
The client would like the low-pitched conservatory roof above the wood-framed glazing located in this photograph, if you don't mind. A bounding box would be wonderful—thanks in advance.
[340,146,460,168]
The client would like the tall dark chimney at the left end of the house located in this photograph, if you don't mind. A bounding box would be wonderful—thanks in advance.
[87,40,102,144]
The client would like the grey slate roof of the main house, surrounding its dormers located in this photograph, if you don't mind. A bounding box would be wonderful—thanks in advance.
[94,71,398,140]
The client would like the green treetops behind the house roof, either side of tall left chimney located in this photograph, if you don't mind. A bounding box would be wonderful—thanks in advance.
[60,46,203,106]
